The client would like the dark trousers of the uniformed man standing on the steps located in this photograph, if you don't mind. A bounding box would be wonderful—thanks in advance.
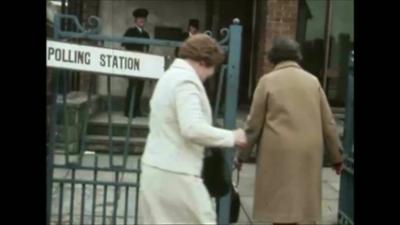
[124,79,144,117]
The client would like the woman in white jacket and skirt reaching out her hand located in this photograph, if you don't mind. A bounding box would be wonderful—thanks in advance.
[139,34,246,224]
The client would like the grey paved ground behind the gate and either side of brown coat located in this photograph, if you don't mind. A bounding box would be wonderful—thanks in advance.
[48,154,339,225]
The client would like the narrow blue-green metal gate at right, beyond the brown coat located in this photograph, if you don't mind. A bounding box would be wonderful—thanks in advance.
[338,51,354,225]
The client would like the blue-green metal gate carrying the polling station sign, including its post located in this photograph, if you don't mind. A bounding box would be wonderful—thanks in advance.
[47,14,242,224]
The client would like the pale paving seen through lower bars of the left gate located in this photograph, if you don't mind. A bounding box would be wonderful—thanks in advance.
[51,154,138,225]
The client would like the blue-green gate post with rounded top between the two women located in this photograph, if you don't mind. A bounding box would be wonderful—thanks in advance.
[218,19,242,224]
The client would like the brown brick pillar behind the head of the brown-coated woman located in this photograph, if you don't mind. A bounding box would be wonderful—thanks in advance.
[257,0,299,79]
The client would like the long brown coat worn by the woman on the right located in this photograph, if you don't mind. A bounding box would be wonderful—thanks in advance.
[240,61,342,223]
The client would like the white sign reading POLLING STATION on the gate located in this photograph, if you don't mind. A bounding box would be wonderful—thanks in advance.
[46,40,164,79]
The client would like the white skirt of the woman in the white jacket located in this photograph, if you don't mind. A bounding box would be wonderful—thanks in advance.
[139,164,217,225]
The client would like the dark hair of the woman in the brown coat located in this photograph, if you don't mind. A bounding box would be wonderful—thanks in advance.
[268,37,303,65]
